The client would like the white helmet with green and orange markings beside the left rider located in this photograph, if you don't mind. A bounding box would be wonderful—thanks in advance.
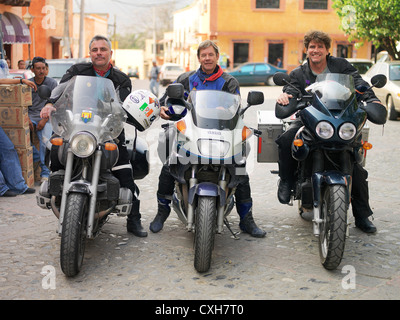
[122,90,161,131]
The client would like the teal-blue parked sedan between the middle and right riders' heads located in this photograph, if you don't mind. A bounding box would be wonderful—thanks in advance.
[228,62,287,86]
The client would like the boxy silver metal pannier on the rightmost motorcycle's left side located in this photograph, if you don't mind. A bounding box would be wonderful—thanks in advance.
[257,110,283,162]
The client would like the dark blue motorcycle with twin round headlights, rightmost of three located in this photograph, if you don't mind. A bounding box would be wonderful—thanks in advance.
[274,73,386,270]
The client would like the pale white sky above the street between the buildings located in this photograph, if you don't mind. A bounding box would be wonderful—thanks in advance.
[73,0,194,34]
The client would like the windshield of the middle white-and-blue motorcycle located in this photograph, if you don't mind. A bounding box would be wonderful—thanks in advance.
[188,90,240,130]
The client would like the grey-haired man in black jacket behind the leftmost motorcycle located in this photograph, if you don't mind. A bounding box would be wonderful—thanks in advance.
[40,35,147,237]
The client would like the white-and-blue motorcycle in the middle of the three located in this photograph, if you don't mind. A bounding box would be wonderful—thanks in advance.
[158,83,264,272]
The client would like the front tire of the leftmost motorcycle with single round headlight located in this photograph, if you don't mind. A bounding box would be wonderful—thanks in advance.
[60,193,88,277]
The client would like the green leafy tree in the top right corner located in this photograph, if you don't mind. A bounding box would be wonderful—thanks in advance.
[333,0,400,60]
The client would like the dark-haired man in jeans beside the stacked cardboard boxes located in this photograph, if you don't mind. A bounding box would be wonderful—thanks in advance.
[28,57,57,182]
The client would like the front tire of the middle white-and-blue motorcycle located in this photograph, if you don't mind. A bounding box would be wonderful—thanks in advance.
[194,196,217,272]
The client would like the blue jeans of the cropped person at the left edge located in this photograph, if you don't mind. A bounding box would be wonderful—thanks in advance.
[0,127,28,195]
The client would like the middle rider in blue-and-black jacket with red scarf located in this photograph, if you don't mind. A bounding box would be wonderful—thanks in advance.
[150,40,266,238]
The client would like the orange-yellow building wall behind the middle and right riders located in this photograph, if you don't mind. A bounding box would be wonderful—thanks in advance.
[200,0,371,70]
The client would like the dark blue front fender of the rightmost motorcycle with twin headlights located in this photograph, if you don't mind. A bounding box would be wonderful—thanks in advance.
[311,171,351,207]
